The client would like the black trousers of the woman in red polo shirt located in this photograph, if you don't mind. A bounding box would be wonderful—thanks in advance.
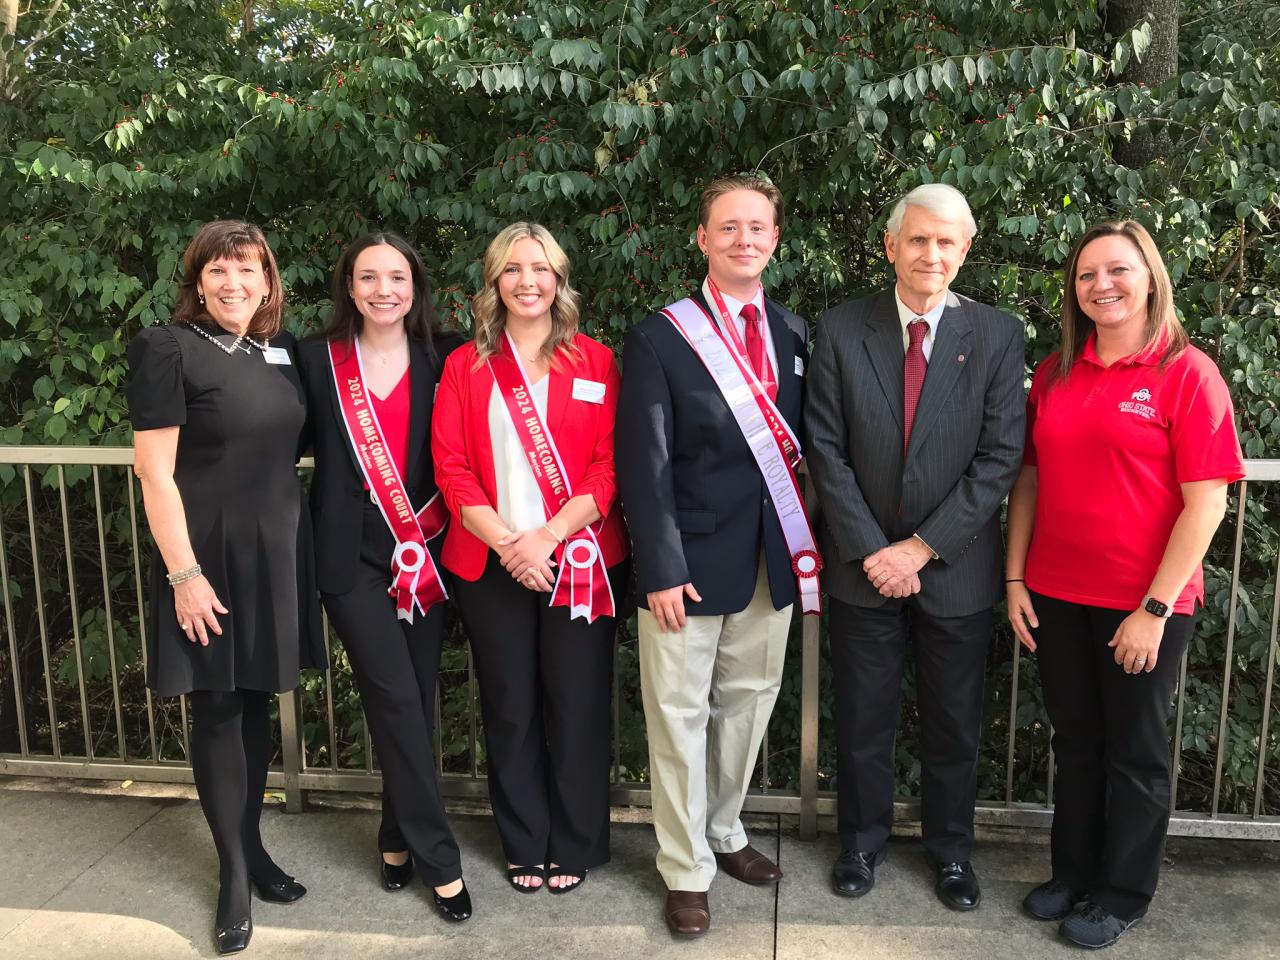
[1032,593,1196,920]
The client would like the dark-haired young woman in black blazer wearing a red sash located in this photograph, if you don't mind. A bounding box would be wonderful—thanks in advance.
[298,233,471,922]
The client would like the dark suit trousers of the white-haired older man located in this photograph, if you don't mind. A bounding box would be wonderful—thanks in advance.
[827,598,992,863]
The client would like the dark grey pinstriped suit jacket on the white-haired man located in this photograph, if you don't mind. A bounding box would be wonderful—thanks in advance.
[805,288,1027,617]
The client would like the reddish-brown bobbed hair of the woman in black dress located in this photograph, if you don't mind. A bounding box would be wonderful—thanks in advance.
[169,220,284,340]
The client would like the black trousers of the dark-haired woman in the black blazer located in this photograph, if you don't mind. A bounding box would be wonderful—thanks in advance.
[321,503,462,887]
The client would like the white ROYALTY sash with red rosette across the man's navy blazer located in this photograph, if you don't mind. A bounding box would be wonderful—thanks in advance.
[662,296,822,613]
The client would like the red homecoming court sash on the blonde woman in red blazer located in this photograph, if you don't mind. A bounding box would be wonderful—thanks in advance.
[488,334,614,623]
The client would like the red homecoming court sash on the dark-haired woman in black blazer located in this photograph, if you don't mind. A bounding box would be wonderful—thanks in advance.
[329,339,449,623]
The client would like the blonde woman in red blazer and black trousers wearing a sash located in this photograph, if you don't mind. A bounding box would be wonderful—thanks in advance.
[431,223,627,893]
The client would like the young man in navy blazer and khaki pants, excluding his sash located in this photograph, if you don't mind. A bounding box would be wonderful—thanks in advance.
[616,177,808,936]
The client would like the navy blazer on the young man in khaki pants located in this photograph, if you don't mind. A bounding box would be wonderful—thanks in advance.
[614,292,808,616]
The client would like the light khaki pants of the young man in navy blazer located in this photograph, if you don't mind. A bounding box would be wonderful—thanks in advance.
[639,559,791,891]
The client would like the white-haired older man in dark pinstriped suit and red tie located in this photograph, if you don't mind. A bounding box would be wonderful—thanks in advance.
[806,184,1025,910]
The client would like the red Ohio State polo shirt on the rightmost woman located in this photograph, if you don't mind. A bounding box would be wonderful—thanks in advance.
[1023,337,1244,613]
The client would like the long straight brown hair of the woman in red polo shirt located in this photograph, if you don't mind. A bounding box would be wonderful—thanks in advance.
[1053,220,1189,380]
